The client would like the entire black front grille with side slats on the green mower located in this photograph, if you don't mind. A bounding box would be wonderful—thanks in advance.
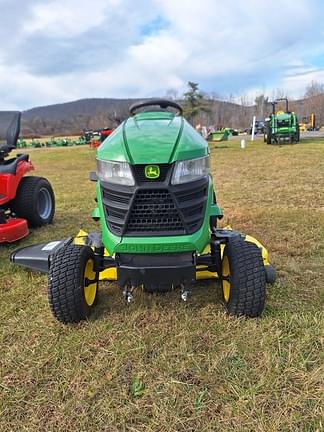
[101,178,208,236]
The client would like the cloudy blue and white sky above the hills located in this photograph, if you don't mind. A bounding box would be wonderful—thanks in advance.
[0,0,324,110]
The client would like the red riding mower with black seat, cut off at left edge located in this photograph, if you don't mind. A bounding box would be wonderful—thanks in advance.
[0,111,55,243]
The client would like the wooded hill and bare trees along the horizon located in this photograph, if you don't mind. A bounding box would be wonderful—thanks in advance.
[22,81,324,136]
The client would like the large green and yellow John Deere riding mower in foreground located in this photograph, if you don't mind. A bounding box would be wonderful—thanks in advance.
[11,100,275,323]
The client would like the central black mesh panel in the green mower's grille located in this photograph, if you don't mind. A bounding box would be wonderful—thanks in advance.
[126,189,185,234]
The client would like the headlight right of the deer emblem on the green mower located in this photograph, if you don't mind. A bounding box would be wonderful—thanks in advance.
[171,156,209,184]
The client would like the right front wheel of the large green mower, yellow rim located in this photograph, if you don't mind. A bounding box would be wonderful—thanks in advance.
[221,239,266,317]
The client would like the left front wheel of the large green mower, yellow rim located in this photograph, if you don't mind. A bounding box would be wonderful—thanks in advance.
[48,243,98,323]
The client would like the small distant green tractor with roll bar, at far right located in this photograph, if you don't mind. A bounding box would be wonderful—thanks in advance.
[264,98,300,144]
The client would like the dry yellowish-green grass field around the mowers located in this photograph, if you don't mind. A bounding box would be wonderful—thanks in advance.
[0,140,324,432]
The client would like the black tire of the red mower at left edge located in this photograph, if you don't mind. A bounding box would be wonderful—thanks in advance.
[11,176,55,227]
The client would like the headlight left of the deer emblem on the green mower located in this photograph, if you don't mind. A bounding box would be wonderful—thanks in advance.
[97,159,135,186]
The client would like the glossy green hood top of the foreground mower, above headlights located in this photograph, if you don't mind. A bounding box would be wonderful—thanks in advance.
[97,111,208,164]
